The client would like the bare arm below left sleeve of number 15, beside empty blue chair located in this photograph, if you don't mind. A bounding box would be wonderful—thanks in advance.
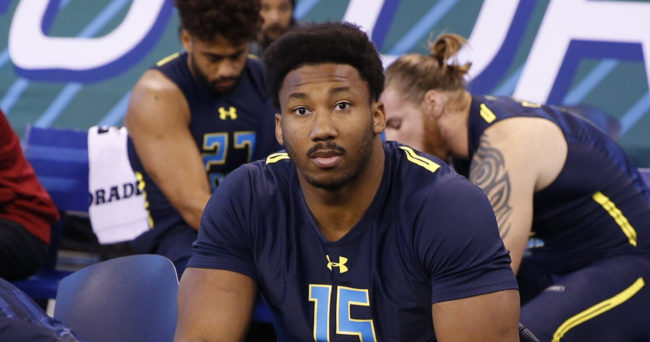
[174,267,256,342]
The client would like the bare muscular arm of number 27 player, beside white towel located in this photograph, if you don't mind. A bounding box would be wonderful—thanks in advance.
[124,70,210,229]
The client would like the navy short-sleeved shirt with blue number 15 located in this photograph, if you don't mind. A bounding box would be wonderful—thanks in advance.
[188,142,517,342]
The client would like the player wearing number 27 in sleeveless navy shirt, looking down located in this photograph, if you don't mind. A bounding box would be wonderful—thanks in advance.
[125,0,280,275]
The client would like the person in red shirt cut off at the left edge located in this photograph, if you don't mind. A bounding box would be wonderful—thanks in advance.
[0,109,59,280]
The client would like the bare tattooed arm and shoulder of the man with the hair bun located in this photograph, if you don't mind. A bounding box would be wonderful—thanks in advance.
[469,118,566,273]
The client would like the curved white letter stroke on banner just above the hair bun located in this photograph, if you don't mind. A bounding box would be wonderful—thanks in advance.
[458,0,519,79]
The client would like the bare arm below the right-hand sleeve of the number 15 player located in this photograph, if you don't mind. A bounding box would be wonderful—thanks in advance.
[431,290,519,342]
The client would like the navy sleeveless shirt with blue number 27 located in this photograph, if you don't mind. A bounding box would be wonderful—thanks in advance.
[128,52,280,244]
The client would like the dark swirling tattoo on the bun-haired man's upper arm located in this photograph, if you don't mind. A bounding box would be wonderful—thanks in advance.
[469,137,512,238]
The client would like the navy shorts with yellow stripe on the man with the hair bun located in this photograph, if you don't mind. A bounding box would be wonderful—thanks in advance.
[517,252,650,342]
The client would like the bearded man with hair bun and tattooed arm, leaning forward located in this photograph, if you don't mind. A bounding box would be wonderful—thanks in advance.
[382,34,650,341]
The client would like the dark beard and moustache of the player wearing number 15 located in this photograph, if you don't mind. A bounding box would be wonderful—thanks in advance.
[282,122,376,191]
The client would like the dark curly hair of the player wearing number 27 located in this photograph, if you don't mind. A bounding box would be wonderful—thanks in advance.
[175,0,263,44]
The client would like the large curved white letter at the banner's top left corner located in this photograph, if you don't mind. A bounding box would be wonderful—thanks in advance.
[9,0,170,80]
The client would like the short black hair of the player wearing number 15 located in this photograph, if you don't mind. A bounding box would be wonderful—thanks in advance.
[263,22,384,108]
